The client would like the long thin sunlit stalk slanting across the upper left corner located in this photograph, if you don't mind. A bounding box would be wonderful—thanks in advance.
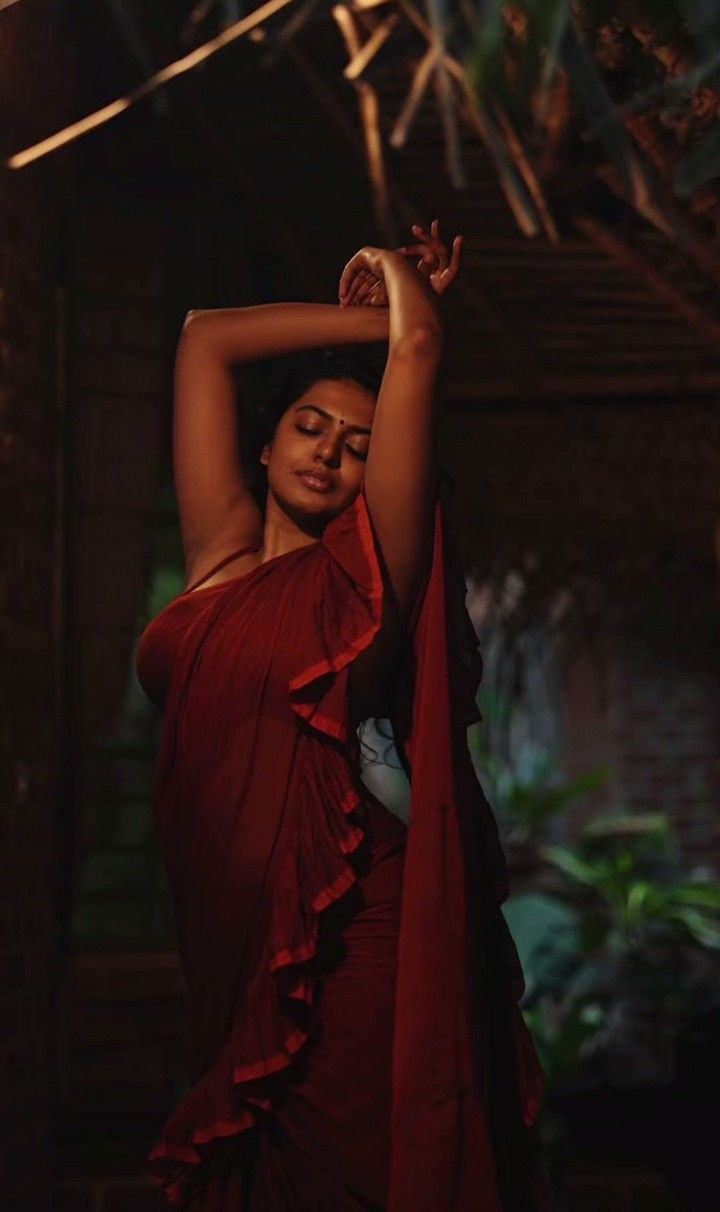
[7,0,293,168]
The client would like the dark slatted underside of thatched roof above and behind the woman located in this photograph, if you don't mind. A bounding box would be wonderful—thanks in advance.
[39,0,720,606]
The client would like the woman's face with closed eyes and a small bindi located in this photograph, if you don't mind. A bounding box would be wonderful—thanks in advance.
[261,379,375,520]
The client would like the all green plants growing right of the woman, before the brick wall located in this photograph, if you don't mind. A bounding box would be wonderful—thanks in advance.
[473,692,720,1082]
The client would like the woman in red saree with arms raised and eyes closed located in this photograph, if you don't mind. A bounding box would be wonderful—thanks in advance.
[137,222,548,1212]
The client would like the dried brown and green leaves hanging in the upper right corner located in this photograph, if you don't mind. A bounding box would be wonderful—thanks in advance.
[458,0,720,233]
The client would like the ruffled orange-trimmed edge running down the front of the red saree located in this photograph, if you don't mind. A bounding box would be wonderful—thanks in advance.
[148,493,383,1208]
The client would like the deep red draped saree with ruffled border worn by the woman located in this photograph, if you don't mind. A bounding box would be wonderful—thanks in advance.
[137,484,550,1212]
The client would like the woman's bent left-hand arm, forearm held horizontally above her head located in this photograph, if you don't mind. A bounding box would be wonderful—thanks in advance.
[173,303,388,569]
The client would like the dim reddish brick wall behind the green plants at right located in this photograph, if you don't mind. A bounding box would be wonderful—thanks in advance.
[564,625,720,874]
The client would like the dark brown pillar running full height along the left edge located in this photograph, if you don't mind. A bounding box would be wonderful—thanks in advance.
[0,2,72,1212]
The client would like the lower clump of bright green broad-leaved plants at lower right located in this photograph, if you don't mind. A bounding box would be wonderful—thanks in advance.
[507,813,720,1081]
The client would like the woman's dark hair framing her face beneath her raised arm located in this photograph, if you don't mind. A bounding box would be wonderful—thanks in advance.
[244,342,388,508]
